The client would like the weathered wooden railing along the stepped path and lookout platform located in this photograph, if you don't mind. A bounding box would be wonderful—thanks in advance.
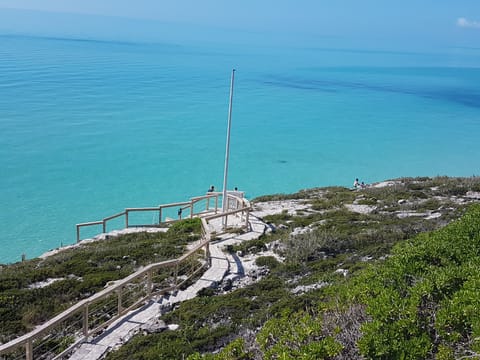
[0,194,250,360]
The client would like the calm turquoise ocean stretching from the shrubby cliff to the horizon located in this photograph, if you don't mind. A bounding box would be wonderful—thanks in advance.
[0,36,480,263]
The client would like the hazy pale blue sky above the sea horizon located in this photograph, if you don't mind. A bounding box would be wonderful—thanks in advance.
[0,0,480,47]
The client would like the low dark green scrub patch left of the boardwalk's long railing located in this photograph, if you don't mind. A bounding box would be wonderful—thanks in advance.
[0,219,200,342]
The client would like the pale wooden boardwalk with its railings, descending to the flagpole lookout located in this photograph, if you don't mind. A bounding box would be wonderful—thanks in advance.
[0,193,255,360]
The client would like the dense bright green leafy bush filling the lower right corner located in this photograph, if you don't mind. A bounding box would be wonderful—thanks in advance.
[349,205,480,359]
